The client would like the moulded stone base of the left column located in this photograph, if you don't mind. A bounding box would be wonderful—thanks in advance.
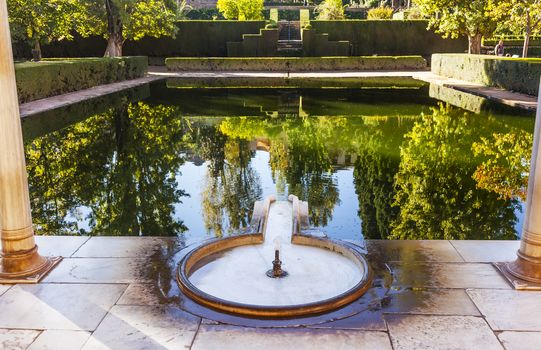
[0,246,62,284]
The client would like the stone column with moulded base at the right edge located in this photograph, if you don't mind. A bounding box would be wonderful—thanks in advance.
[497,80,541,289]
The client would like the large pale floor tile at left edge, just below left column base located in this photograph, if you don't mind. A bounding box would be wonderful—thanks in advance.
[0,283,127,331]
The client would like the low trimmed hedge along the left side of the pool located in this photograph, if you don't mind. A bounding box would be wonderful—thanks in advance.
[15,56,148,103]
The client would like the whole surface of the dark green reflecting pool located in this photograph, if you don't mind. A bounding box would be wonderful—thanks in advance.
[23,84,534,239]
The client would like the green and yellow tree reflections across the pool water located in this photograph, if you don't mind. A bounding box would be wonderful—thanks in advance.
[26,90,533,239]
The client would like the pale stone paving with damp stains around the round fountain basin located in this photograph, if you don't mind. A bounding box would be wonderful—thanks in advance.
[0,237,541,350]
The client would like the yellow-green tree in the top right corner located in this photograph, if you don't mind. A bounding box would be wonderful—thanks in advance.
[496,0,541,57]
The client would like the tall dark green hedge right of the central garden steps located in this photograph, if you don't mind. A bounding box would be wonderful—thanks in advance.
[310,20,468,57]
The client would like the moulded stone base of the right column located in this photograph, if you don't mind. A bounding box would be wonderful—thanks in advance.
[494,254,541,290]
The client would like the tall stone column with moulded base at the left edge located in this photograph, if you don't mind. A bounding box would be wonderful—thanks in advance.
[0,0,60,283]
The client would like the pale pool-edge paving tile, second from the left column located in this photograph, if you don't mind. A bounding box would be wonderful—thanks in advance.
[73,237,173,258]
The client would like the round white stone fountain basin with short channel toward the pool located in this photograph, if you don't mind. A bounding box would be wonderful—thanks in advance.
[178,201,370,317]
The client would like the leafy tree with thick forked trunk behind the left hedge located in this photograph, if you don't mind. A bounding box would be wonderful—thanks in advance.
[77,0,179,57]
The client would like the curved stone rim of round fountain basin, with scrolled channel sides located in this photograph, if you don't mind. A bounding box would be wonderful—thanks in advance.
[177,196,373,318]
